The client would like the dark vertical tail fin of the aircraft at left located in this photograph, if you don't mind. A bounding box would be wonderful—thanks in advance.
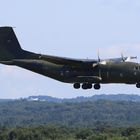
[0,27,23,61]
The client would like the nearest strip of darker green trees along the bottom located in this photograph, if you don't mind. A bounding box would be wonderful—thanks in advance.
[0,125,140,140]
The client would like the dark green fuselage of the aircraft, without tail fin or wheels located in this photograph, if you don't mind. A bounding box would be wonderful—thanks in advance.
[4,55,140,89]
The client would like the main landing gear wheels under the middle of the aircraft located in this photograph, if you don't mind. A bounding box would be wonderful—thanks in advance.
[73,83,101,90]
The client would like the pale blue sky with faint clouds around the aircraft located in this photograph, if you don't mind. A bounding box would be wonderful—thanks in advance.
[0,0,140,98]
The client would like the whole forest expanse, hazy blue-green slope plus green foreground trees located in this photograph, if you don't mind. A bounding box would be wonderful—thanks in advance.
[0,100,140,140]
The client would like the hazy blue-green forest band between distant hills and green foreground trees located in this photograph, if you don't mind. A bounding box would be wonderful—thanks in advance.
[0,100,140,127]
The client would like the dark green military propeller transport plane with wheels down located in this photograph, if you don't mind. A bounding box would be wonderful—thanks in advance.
[0,27,140,89]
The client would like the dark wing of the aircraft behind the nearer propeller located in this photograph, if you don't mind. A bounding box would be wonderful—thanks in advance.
[40,55,98,66]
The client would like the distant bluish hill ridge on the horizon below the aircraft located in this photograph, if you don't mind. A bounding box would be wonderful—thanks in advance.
[25,94,140,103]
